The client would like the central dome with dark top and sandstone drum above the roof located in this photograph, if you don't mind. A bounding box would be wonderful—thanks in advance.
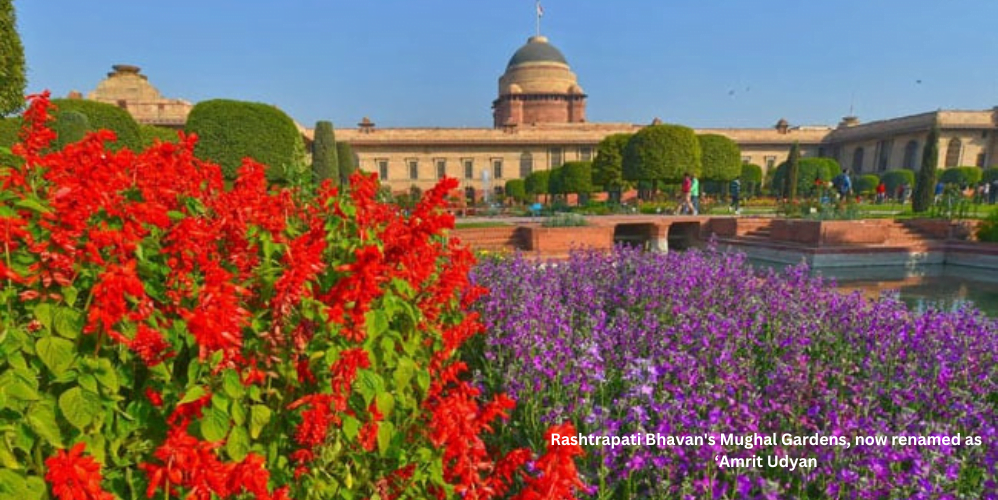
[492,35,586,128]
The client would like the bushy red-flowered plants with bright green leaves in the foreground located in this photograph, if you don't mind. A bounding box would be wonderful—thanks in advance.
[0,92,581,500]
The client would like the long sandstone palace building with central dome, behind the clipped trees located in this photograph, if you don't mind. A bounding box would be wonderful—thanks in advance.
[82,36,998,194]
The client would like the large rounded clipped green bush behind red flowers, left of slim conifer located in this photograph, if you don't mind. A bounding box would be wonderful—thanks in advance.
[186,99,301,182]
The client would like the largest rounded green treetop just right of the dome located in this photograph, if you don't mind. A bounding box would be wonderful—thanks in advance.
[623,125,702,182]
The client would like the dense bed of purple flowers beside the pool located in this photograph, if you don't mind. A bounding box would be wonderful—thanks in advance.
[469,249,998,499]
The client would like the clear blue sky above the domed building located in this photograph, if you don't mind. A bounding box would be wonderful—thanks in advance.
[14,0,998,127]
